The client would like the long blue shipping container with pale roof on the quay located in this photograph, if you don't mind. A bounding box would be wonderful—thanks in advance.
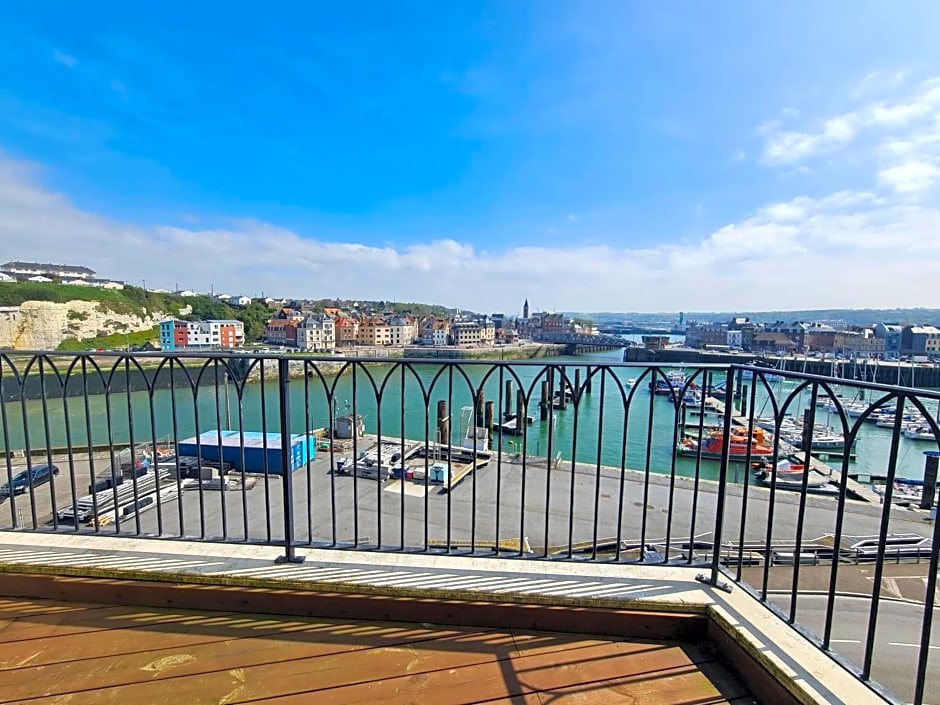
[176,429,317,475]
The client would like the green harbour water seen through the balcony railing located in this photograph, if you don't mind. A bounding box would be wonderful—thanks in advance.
[0,351,931,480]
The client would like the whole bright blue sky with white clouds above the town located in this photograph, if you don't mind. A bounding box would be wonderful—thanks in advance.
[0,2,940,311]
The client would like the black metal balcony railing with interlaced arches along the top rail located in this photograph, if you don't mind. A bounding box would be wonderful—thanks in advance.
[0,353,940,703]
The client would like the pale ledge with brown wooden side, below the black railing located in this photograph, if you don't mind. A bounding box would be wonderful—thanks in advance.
[0,532,886,705]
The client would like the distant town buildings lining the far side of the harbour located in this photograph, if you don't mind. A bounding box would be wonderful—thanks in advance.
[0,261,940,361]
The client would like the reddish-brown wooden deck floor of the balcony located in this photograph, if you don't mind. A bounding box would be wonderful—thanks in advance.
[0,598,755,705]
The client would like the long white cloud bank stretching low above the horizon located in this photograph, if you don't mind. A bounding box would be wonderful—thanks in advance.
[0,155,940,311]
